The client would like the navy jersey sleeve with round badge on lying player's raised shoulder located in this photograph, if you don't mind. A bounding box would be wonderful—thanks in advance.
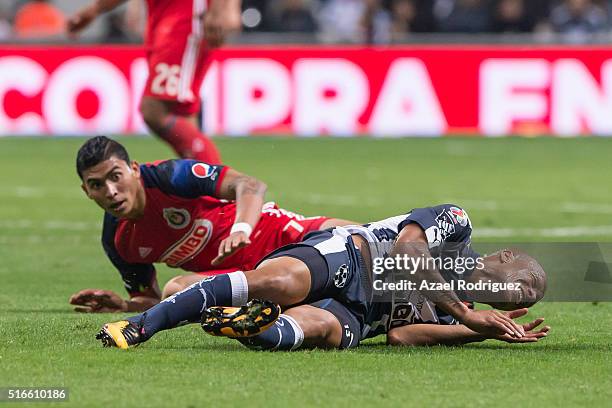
[398,204,472,249]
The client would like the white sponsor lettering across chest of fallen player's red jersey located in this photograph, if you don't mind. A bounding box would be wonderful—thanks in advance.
[159,219,213,268]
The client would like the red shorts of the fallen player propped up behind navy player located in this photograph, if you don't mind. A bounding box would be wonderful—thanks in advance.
[198,203,330,275]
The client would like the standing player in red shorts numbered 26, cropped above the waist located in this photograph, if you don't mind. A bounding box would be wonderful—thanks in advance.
[67,0,241,164]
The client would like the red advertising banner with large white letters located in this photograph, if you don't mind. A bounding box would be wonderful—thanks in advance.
[0,46,612,137]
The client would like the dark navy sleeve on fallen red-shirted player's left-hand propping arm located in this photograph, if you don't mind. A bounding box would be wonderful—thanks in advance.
[102,214,156,297]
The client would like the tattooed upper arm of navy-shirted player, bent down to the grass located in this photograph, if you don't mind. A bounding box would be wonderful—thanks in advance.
[389,224,525,338]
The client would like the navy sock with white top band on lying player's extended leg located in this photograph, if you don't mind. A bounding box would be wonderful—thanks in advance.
[127,271,248,340]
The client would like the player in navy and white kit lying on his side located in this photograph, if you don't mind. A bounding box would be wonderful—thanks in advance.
[98,204,548,350]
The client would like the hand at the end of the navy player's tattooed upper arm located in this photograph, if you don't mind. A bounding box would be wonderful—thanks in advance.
[461,309,527,339]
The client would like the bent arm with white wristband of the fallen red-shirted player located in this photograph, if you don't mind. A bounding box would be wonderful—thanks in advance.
[212,169,268,266]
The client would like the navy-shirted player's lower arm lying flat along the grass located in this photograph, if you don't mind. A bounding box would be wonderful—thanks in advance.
[387,309,550,346]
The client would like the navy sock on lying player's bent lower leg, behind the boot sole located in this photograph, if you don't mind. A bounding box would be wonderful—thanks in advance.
[238,314,304,351]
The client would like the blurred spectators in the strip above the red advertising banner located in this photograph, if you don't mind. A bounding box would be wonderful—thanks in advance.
[0,0,611,44]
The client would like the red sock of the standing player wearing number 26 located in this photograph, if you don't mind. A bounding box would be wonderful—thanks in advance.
[160,115,221,164]
